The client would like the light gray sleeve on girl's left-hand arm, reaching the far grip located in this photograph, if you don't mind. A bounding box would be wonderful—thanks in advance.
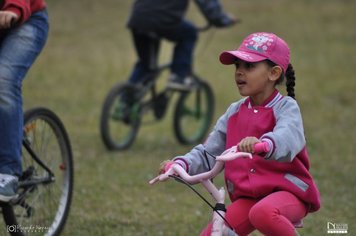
[173,101,245,175]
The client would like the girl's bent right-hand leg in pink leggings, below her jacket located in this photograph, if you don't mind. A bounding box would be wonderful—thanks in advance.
[249,191,307,236]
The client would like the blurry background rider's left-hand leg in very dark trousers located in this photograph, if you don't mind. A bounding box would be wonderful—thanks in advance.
[129,30,159,84]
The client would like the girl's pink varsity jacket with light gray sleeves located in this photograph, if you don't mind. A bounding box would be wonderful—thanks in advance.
[174,90,320,212]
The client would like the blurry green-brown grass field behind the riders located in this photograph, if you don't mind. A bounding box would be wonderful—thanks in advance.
[6,0,356,236]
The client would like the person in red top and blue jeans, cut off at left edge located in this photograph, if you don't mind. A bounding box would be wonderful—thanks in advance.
[0,0,48,202]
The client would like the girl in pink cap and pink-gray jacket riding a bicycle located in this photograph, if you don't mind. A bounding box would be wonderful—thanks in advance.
[154,32,320,236]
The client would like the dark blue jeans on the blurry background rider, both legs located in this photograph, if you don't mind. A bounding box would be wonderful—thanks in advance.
[129,21,198,83]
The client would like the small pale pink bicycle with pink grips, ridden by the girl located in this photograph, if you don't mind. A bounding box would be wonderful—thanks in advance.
[149,142,269,236]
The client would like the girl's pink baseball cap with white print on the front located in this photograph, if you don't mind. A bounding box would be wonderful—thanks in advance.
[220,32,290,73]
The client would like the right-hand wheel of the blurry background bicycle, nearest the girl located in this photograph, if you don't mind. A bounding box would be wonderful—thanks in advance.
[173,79,214,145]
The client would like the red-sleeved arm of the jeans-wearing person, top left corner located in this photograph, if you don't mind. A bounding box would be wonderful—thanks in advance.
[1,0,31,25]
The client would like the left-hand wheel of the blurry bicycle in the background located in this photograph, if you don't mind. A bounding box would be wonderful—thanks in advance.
[100,84,141,150]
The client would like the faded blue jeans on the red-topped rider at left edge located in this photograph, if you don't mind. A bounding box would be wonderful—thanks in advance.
[0,10,48,176]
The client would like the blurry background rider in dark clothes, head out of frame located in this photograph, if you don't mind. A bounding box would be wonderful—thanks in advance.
[128,0,234,90]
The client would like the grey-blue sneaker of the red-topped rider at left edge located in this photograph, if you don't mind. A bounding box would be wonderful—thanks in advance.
[0,174,19,202]
